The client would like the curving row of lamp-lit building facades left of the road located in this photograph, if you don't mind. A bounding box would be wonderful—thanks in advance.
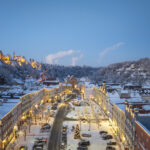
[0,88,63,150]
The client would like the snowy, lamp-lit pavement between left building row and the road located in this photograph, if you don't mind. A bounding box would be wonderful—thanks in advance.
[6,111,54,150]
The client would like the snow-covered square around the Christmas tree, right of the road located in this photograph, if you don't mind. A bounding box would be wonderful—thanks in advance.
[63,99,119,150]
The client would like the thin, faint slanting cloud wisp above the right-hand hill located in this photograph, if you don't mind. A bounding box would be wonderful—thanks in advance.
[99,42,124,61]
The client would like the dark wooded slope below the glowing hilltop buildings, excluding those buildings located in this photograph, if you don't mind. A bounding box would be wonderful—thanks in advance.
[0,61,98,84]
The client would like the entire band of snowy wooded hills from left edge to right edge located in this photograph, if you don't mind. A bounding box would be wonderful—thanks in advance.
[0,58,150,84]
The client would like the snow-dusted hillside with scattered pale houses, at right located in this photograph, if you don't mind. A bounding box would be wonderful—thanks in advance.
[92,58,150,85]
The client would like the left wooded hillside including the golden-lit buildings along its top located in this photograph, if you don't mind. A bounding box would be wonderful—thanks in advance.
[0,50,98,84]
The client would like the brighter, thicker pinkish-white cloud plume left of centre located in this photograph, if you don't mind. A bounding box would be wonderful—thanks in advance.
[45,50,75,64]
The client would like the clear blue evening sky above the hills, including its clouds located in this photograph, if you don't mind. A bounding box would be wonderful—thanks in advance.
[0,0,150,66]
